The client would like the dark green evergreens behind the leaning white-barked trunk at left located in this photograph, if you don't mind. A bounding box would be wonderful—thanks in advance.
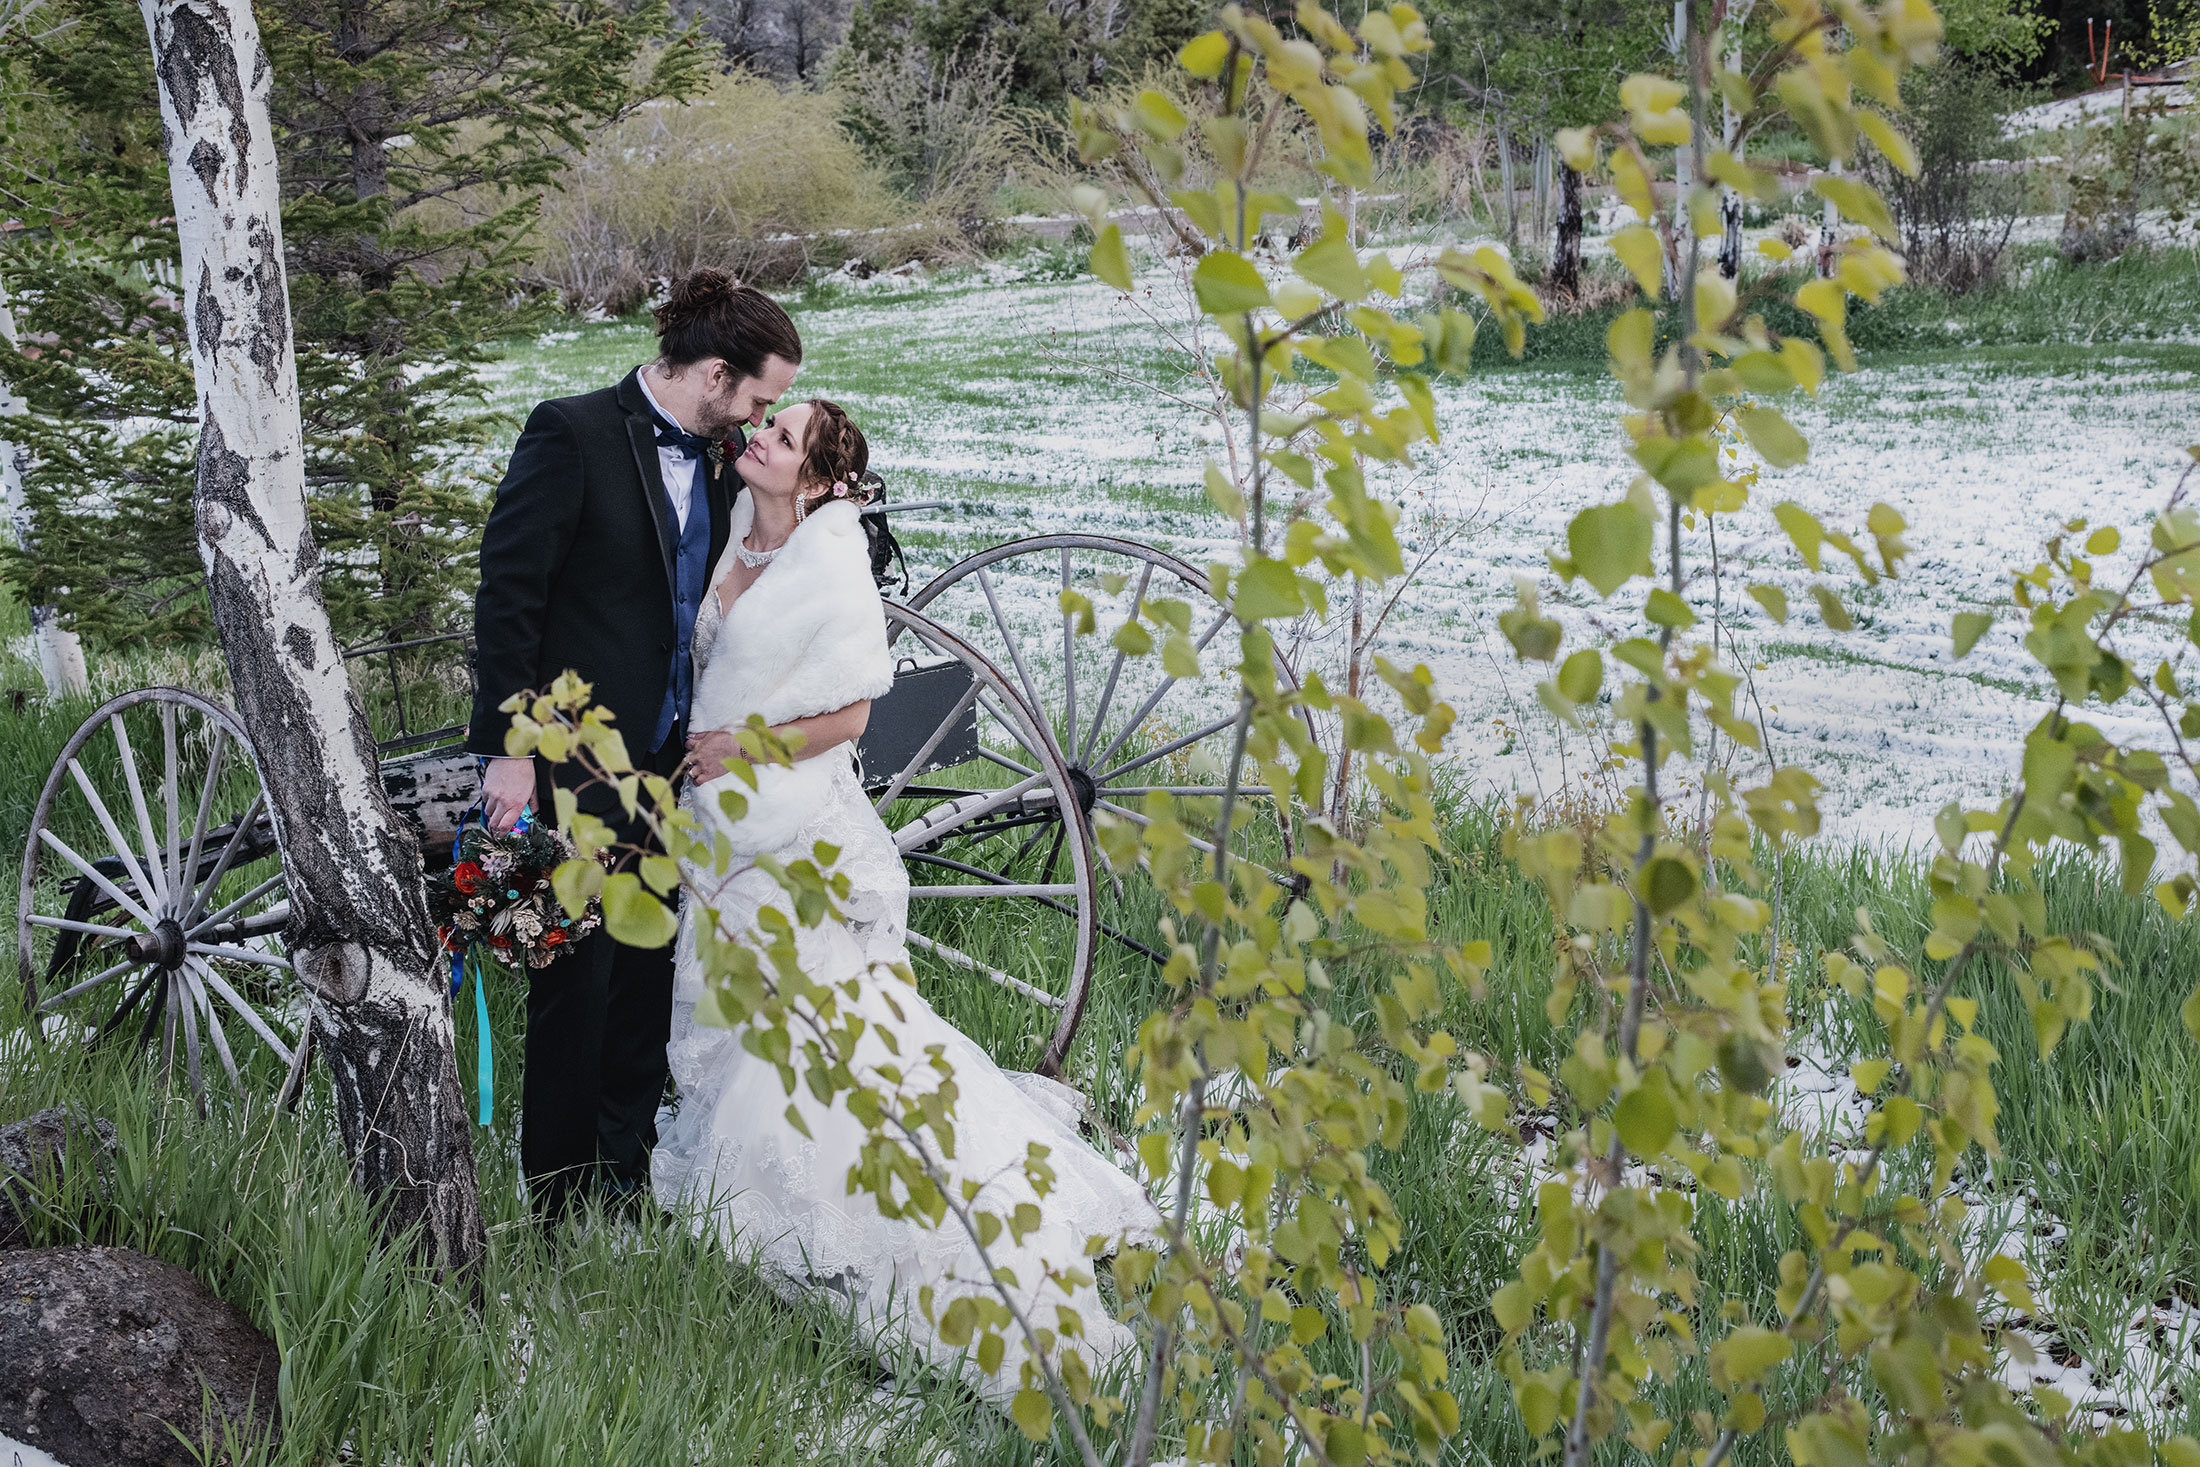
[0,0,706,644]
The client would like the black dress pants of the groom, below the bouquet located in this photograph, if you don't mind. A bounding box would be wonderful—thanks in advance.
[519,737,682,1221]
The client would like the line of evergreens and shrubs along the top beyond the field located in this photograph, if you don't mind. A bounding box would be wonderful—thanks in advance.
[0,0,2182,664]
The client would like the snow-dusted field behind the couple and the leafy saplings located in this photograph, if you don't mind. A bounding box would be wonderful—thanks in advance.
[481,264,2200,845]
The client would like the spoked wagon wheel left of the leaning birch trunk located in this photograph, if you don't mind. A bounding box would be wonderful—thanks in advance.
[15,688,308,1111]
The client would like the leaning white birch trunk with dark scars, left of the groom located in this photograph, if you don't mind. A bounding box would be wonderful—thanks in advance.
[141,0,482,1269]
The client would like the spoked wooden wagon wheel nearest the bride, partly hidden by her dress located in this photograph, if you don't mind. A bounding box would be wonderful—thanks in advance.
[860,603,1098,1076]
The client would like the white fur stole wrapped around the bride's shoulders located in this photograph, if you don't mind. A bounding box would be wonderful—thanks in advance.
[689,495,893,856]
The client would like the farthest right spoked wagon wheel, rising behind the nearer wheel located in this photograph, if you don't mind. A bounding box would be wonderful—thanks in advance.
[909,534,1313,928]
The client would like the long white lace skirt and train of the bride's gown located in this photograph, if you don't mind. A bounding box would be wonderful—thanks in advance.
[651,611,1157,1403]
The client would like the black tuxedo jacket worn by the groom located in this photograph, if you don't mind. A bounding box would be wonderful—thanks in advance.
[466,372,744,814]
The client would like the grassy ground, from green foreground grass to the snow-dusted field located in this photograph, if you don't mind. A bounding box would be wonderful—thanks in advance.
[0,238,2200,1465]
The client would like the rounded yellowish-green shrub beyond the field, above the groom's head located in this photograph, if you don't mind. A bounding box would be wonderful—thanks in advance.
[541,73,904,315]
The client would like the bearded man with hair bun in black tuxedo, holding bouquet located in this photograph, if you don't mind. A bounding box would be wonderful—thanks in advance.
[466,271,803,1218]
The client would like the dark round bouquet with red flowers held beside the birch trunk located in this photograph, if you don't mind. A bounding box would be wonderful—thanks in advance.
[427,825,603,970]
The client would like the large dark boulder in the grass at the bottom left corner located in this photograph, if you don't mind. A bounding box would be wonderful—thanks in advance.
[0,1247,282,1467]
